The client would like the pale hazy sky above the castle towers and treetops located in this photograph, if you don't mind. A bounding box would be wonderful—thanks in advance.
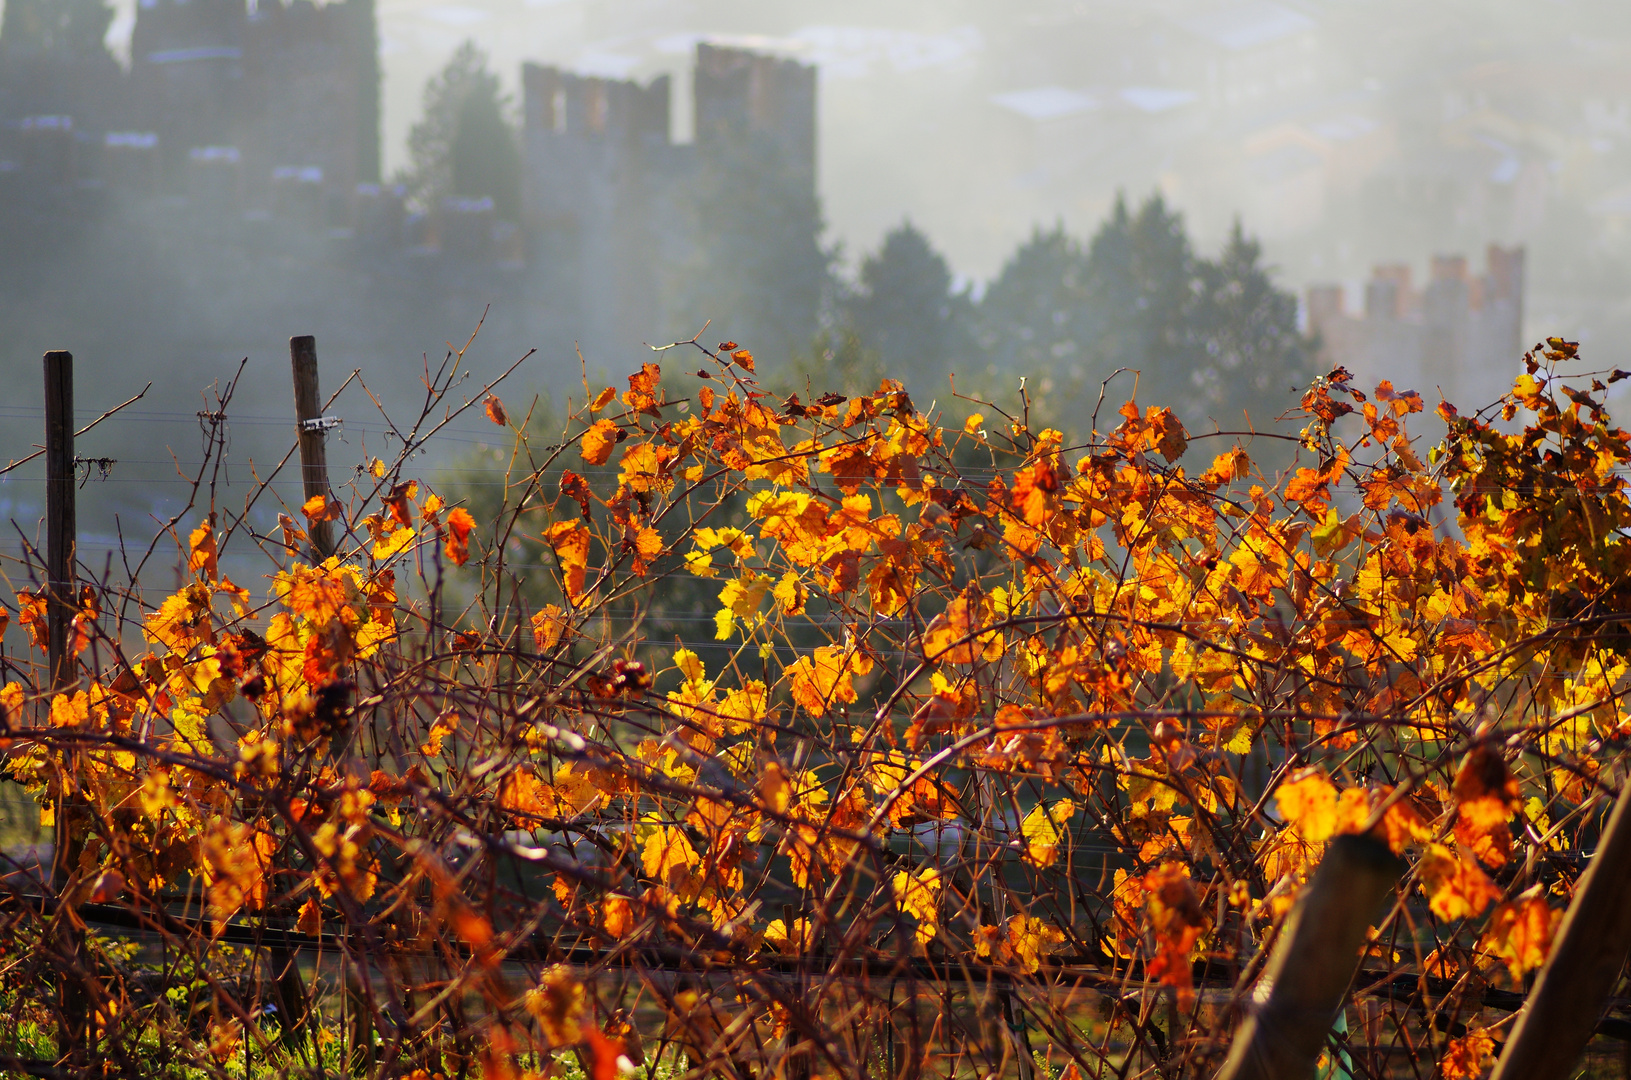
[86,0,1631,313]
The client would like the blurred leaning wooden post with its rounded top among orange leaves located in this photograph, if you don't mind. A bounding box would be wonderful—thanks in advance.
[1217,835,1404,1080]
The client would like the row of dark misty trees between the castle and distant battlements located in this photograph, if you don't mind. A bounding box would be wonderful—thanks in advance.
[829,196,1315,429]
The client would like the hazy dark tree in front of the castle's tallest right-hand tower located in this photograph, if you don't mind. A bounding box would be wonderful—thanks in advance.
[680,135,832,364]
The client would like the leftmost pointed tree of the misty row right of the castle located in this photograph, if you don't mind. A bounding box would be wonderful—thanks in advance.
[843,222,974,385]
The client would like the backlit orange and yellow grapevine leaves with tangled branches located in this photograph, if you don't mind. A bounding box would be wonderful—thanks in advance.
[0,341,1631,1078]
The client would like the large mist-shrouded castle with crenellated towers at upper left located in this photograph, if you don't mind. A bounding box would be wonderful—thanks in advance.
[0,0,816,363]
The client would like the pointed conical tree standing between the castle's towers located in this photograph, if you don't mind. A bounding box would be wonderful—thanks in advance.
[406,41,522,220]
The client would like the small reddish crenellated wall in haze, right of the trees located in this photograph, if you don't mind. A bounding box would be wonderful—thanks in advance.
[1308,245,1523,411]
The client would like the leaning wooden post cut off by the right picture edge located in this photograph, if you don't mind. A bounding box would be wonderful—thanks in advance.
[1491,780,1631,1080]
